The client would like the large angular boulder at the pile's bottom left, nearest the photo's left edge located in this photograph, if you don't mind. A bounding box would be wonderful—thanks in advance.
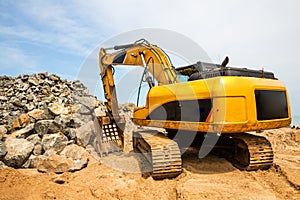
[2,138,34,168]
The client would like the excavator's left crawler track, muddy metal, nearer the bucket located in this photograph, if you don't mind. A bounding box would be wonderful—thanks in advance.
[133,130,182,179]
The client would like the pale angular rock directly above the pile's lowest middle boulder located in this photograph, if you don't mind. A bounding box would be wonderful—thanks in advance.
[42,132,68,153]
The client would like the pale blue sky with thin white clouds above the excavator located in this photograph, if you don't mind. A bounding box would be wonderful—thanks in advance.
[0,0,300,116]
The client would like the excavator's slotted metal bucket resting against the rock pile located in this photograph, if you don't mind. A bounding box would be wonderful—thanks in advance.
[95,116,125,157]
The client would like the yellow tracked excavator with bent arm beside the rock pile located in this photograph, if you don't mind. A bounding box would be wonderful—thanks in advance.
[97,39,291,179]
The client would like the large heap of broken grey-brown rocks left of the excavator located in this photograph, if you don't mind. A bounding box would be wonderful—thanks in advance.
[0,72,105,173]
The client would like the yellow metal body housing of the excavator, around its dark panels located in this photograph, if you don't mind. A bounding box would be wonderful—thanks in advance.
[134,76,291,133]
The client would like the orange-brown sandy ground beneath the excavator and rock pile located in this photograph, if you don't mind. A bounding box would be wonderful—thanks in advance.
[0,129,300,200]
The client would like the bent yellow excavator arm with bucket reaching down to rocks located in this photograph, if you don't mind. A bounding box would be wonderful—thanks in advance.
[98,39,179,153]
